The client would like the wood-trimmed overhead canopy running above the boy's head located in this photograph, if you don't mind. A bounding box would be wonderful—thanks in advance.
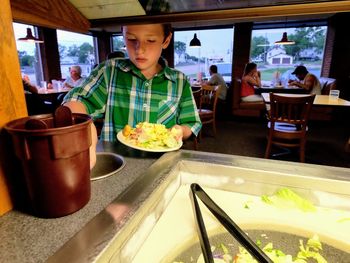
[69,0,350,32]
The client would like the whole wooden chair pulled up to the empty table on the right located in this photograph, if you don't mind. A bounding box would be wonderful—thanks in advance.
[265,93,315,162]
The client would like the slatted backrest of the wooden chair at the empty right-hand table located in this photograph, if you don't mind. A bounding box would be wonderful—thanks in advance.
[270,92,315,130]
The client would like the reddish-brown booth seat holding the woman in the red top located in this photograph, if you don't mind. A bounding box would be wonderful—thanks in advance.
[232,79,265,117]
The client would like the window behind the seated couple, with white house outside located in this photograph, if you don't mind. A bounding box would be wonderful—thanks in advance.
[250,26,327,85]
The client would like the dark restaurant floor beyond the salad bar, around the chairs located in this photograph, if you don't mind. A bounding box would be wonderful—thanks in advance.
[183,118,350,168]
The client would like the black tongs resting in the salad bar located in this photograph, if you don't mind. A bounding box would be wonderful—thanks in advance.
[190,184,273,263]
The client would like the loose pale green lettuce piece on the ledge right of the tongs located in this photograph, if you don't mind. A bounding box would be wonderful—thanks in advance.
[261,188,316,212]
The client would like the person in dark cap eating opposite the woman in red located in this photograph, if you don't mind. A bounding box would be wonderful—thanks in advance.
[288,66,321,95]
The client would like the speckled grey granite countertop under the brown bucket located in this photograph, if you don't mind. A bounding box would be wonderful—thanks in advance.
[0,142,162,263]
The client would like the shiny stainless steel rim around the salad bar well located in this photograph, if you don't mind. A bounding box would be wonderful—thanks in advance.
[49,151,350,262]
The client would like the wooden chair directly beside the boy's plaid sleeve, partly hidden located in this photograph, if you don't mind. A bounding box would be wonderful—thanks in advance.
[198,85,219,137]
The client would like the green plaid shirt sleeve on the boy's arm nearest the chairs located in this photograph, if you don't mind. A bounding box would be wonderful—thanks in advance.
[178,79,202,136]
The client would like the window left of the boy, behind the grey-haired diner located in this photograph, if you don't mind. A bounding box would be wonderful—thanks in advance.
[57,30,96,79]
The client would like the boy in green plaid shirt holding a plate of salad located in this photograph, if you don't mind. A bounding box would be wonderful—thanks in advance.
[63,24,202,167]
